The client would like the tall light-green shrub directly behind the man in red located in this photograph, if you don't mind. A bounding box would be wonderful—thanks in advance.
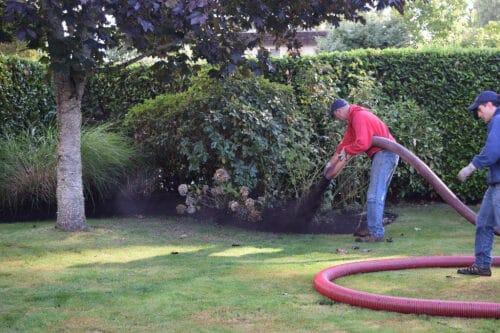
[291,62,373,208]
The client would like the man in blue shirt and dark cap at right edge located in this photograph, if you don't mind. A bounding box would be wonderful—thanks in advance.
[457,91,500,276]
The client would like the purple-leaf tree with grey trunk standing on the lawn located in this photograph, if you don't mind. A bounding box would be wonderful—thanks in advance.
[0,0,404,231]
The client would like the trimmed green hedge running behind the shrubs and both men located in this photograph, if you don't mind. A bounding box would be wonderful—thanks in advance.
[0,48,500,201]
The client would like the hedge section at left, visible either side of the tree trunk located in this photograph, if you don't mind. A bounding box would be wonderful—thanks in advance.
[0,55,197,132]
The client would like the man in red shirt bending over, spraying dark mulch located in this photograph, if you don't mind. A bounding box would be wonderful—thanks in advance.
[323,99,399,242]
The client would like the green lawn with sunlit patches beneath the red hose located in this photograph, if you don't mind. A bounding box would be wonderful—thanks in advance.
[0,205,500,332]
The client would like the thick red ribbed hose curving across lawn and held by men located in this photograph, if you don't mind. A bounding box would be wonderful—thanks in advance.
[314,137,500,318]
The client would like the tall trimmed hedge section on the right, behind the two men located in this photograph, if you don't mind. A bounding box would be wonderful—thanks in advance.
[268,48,500,201]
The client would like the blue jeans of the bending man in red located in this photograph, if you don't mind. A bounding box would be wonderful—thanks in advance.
[366,150,399,237]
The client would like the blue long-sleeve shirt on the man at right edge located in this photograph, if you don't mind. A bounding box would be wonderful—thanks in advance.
[472,108,500,185]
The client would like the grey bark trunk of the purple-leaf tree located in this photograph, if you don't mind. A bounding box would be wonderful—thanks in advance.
[54,71,87,231]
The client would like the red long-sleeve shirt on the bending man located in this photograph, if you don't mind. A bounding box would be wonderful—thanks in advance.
[336,104,396,158]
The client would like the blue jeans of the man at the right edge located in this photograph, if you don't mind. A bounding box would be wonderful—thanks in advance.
[475,185,500,268]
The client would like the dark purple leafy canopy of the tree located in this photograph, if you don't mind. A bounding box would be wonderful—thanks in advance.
[0,0,404,71]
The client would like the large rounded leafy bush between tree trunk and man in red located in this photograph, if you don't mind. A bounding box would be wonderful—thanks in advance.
[126,72,314,202]
